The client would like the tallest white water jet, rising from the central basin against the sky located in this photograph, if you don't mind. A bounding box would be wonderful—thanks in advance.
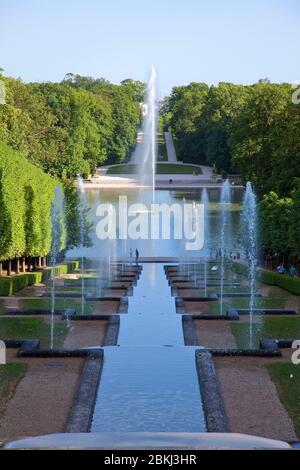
[131,66,158,203]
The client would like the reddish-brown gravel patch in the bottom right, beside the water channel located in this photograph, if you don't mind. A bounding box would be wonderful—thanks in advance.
[214,357,297,440]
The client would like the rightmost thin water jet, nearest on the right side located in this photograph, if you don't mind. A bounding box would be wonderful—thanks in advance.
[242,182,257,348]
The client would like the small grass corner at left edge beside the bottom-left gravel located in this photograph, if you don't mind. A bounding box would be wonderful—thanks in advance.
[0,362,27,415]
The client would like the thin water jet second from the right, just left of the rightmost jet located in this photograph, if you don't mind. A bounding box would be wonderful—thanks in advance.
[220,179,231,315]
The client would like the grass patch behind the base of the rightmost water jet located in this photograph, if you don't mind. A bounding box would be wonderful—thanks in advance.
[230,315,300,348]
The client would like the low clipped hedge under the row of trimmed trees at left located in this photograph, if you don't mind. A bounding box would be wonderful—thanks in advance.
[0,261,79,296]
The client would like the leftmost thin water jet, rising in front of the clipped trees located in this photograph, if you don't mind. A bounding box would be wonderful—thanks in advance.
[50,186,65,349]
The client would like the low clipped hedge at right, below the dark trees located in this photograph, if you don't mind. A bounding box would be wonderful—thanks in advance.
[228,261,300,295]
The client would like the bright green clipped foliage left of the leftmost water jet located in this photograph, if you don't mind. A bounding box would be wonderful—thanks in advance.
[0,143,63,262]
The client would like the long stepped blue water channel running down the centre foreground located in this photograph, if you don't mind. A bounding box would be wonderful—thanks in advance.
[91,263,205,432]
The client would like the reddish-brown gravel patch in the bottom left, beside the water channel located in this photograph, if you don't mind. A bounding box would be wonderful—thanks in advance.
[0,350,84,440]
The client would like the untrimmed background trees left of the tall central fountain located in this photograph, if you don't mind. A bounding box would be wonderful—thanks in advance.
[0,74,144,177]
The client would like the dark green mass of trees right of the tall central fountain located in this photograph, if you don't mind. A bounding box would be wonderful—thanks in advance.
[162,79,300,259]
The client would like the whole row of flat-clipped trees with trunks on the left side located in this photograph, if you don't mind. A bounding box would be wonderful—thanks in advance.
[0,143,91,276]
